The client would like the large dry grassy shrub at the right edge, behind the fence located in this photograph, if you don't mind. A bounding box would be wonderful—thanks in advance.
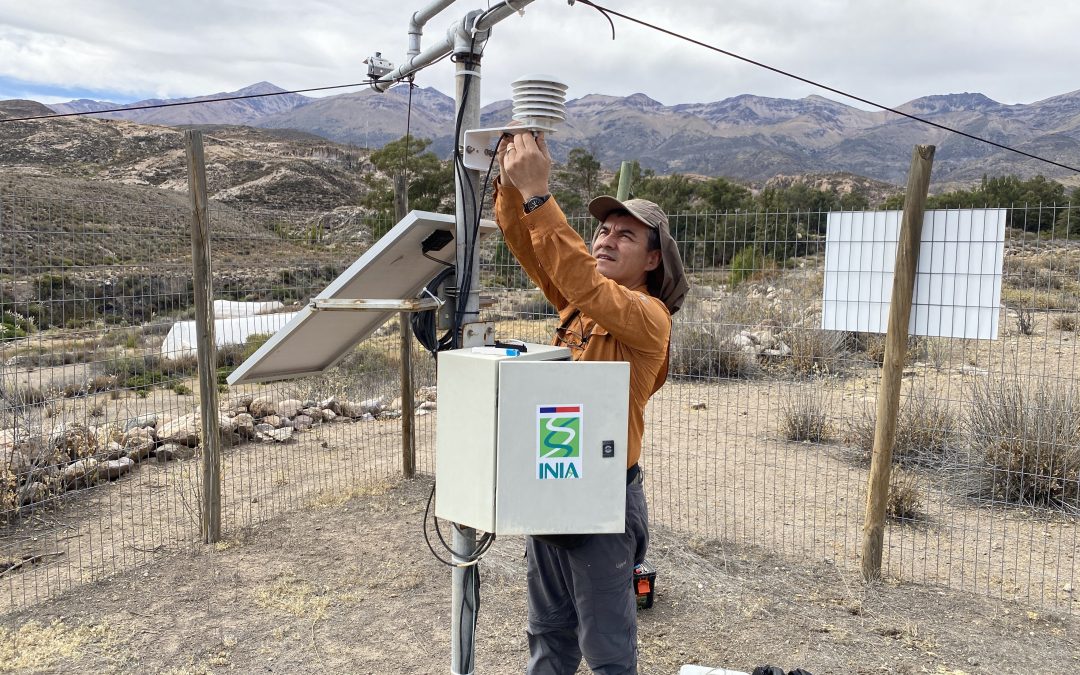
[968,375,1080,512]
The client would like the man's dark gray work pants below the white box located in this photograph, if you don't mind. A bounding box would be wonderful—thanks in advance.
[526,477,649,675]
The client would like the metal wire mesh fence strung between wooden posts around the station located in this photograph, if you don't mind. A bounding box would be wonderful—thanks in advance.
[0,190,1080,612]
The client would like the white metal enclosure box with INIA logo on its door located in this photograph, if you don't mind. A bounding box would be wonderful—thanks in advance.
[435,345,630,535]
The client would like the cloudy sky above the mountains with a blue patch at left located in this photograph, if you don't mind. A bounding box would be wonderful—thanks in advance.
[0,0,1080,108]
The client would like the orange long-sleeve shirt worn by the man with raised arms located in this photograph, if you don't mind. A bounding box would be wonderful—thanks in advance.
[495,184,672,468]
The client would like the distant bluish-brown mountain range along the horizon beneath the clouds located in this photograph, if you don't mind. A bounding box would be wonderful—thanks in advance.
[33,82,1080,186]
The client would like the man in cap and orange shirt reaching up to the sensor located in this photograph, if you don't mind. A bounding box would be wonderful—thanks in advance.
[495,127,687,675]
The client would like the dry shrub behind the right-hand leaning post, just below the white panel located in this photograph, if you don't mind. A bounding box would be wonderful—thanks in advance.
[848,388,960,467]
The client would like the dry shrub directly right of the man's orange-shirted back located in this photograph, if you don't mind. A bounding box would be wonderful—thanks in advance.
[670,323,760,378]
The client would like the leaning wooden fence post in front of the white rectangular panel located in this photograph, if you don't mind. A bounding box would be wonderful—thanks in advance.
[862,146,935,581]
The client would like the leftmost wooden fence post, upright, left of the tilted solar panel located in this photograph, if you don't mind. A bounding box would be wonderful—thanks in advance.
[184,131,221,543]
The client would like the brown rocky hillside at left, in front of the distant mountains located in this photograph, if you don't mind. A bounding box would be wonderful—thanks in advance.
[0,102,393,270]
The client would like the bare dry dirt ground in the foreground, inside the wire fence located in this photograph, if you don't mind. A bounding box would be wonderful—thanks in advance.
[0,478,1080,675]
